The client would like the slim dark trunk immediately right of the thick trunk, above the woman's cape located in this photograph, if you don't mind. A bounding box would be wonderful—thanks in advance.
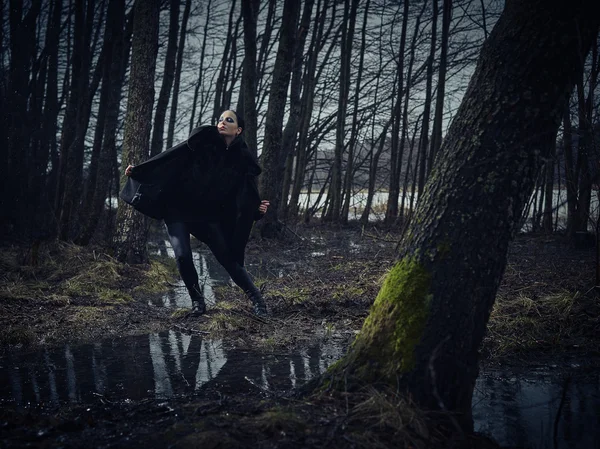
[150,0,180,156]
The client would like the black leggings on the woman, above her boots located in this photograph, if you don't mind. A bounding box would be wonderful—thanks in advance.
[166,221,257,293]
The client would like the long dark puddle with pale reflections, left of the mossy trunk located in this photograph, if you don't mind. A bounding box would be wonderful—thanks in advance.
[0,330,344,405]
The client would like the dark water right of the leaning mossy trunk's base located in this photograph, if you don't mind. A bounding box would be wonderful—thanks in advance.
[473,371,600,449]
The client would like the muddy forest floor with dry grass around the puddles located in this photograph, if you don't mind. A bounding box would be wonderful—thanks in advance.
[0,221,600,448]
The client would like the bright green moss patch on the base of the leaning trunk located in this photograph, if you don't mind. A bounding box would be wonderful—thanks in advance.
[342,258,431,379]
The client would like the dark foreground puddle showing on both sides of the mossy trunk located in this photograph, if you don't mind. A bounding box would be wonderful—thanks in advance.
[0,330,600,449]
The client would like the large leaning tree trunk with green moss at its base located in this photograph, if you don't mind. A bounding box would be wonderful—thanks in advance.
[324,0,600,430]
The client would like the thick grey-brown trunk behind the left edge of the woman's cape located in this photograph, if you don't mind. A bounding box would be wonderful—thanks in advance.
[114,0,159,263]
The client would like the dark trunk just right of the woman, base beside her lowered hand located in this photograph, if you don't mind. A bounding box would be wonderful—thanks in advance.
[259,0,300,237]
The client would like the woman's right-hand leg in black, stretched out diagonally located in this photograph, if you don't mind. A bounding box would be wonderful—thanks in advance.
[192,223,267,315]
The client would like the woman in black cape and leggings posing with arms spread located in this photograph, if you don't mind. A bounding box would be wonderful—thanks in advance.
[121,110,269,316]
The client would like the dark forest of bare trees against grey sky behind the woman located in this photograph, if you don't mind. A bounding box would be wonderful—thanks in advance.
[0,0,600,252]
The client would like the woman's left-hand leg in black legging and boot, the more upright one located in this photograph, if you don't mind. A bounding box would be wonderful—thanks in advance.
[165,222,206,313]
